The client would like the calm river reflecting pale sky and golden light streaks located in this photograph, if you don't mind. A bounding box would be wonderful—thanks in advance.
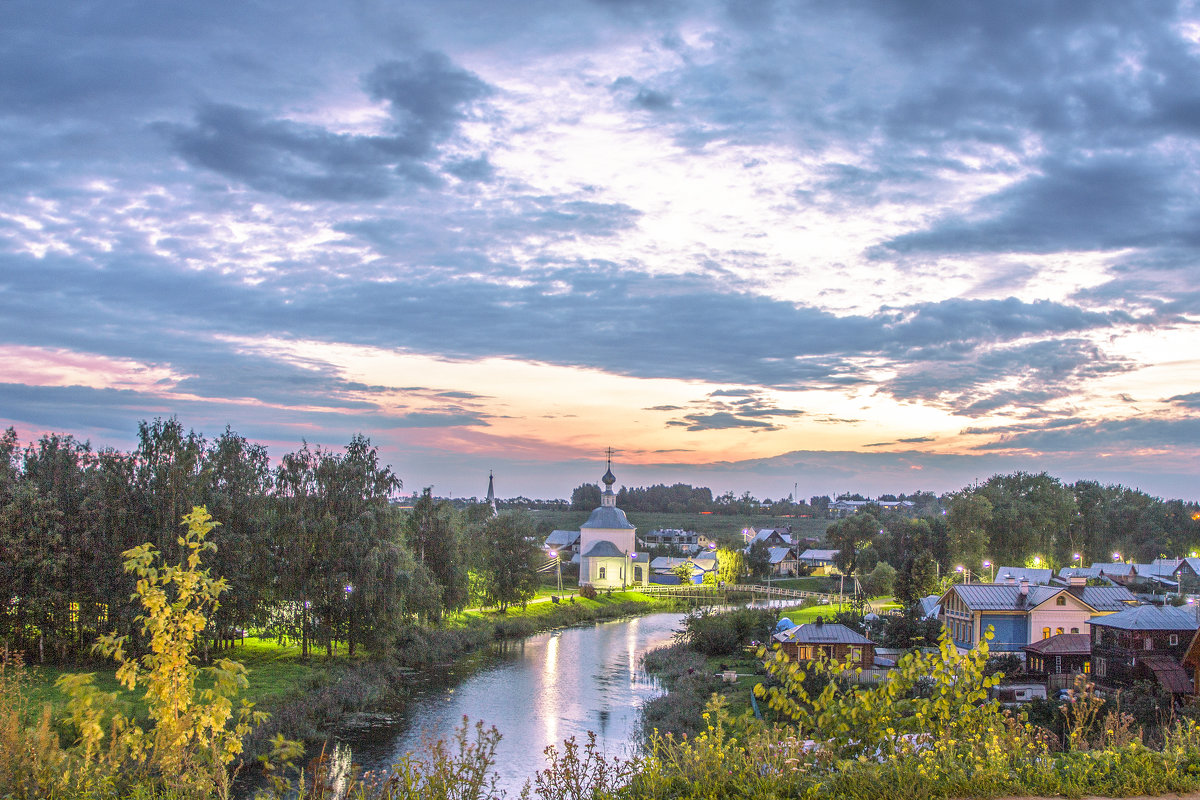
[334,613,683,796]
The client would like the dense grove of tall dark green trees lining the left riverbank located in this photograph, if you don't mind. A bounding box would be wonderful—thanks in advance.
[0,419,533,661]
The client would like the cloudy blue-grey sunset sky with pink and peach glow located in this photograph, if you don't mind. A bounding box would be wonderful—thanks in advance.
[0,0,1200,499]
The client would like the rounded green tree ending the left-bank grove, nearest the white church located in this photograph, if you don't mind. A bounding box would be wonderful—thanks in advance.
[475,511,541,612]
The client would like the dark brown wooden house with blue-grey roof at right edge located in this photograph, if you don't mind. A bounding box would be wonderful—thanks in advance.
[1091,606,1200,694]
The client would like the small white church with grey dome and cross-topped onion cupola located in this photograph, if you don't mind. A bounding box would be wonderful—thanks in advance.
[580,450,650,589]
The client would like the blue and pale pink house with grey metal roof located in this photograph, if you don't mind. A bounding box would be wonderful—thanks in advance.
[940,578,1136,655]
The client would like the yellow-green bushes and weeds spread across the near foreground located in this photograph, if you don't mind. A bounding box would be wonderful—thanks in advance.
[7,544,1200,800]
